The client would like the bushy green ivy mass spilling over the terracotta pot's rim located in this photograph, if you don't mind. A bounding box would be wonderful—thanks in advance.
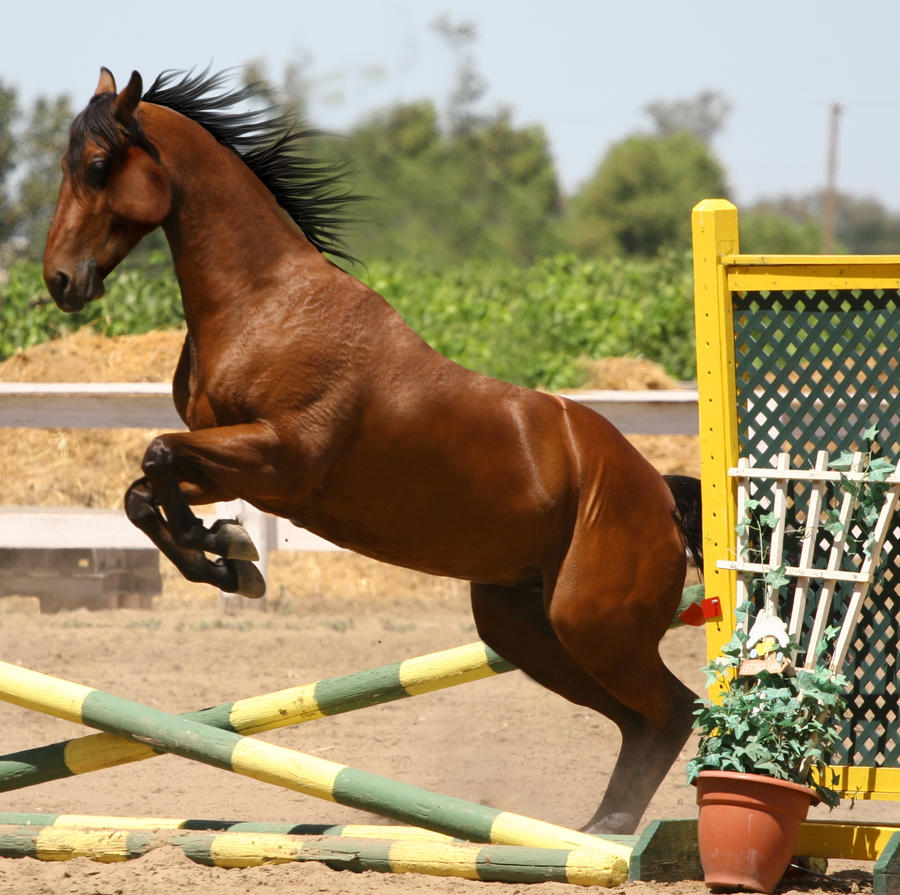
[687,603,847,806]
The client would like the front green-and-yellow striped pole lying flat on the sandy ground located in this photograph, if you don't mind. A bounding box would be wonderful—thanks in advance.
[0,826,624,886]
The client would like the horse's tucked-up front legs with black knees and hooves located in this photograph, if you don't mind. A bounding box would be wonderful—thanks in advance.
[125,423,279,597]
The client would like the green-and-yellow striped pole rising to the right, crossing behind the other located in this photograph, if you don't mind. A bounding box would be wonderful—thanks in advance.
[0,641,515,792]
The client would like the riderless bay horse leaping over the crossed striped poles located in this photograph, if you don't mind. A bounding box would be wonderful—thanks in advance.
[44,68,694,833]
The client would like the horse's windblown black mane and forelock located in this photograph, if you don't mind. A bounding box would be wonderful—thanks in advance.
[68,71,357,263]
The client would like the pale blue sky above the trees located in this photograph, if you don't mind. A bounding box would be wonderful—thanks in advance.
[0,0,900,213]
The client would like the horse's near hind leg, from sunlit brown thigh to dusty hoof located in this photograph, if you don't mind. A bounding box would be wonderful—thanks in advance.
[548,532,696,832]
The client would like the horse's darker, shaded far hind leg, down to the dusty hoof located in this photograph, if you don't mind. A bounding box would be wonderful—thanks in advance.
[472,584,694,833]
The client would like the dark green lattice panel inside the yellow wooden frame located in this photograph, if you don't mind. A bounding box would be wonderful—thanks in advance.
[733,290,900,767]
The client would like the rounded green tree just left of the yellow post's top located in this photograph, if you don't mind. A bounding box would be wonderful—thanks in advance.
[564,130,728,256]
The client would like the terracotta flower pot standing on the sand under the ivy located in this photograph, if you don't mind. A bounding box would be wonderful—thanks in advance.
[697,771,819,892]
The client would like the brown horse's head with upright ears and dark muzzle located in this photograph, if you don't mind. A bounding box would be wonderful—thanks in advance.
[44,68,172,311]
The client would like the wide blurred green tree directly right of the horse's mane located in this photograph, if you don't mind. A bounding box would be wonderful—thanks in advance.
[342,100,559,265]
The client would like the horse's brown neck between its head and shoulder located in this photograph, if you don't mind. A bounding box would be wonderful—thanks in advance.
[148,107,328,334]
